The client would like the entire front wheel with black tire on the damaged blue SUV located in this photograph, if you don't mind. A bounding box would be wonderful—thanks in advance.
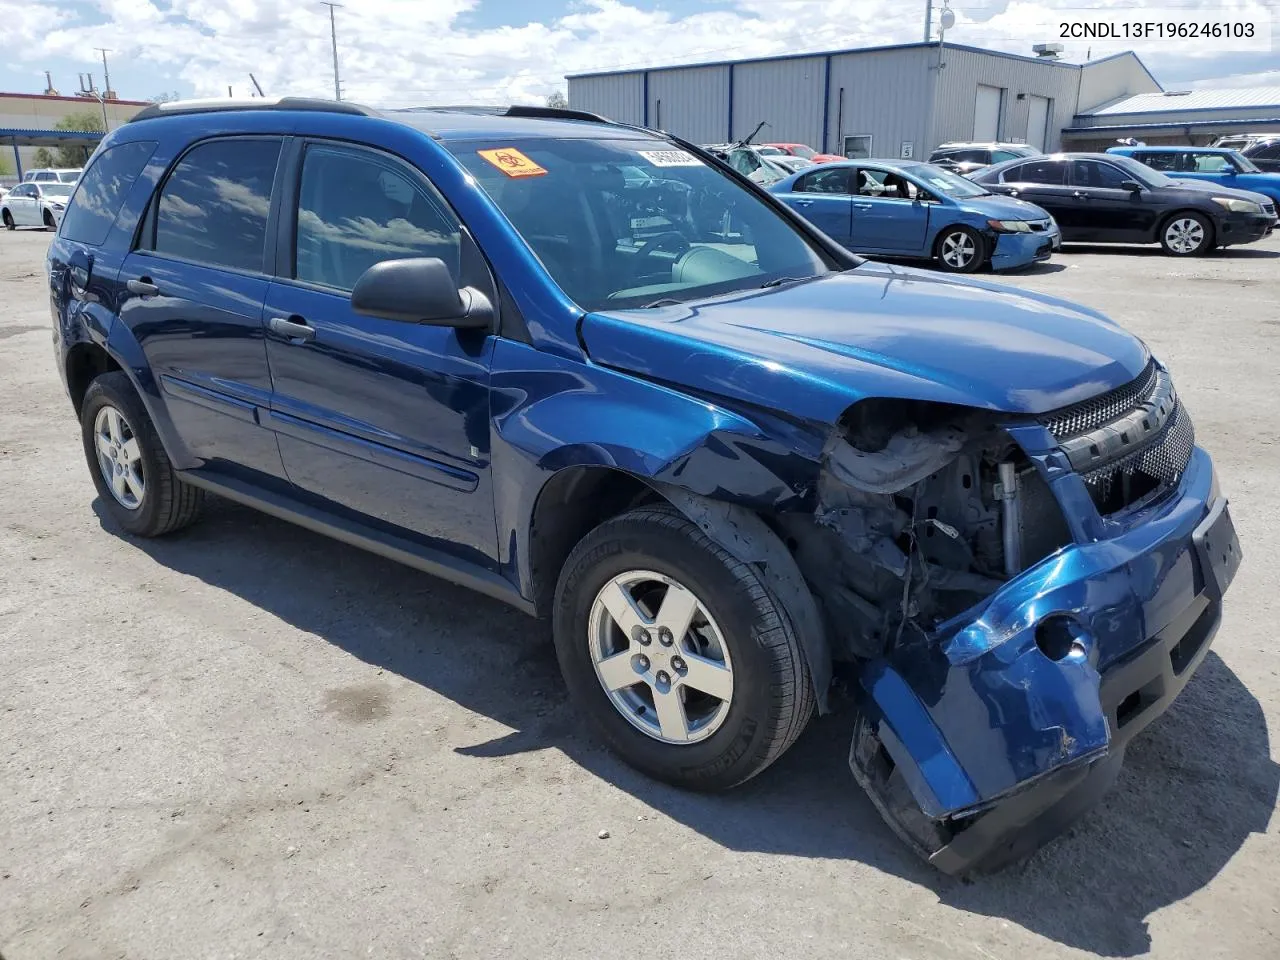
[553,506,814,790]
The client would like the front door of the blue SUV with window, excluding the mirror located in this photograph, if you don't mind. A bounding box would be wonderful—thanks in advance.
[266,141,497,566]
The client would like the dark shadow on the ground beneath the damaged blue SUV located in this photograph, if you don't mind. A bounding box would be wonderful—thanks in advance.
[95,498,1280,956]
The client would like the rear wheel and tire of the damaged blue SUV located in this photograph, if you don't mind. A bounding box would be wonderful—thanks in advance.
[81,370,205,536]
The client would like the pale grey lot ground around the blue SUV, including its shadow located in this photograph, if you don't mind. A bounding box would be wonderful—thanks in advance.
[0,232,1280,960]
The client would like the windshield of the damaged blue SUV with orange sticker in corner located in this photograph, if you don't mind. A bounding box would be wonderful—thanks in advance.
[447,140,829,310]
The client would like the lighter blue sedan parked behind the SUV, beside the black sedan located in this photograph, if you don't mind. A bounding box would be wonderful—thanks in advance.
[769,160,1061,273]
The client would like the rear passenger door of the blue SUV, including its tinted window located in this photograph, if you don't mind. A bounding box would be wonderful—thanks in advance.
[119,136,284,483]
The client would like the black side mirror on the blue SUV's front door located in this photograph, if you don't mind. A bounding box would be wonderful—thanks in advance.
[351,257,493,328]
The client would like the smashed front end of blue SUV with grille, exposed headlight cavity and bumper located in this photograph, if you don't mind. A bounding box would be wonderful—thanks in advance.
[778,364,1239,873]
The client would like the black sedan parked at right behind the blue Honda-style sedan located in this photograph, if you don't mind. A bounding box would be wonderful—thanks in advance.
[970,154,1276,257]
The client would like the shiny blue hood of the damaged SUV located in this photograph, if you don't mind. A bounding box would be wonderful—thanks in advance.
[581,262,1149,424]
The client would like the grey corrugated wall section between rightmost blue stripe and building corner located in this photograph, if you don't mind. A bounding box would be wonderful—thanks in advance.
[810,49,932,160]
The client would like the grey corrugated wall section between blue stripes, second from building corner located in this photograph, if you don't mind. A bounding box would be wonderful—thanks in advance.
[733,56,826,145]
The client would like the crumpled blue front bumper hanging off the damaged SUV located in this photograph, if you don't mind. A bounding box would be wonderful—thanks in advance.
[850,448,1240,873]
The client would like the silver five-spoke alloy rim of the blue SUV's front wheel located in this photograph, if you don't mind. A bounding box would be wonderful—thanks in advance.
[588,570,733,744]
